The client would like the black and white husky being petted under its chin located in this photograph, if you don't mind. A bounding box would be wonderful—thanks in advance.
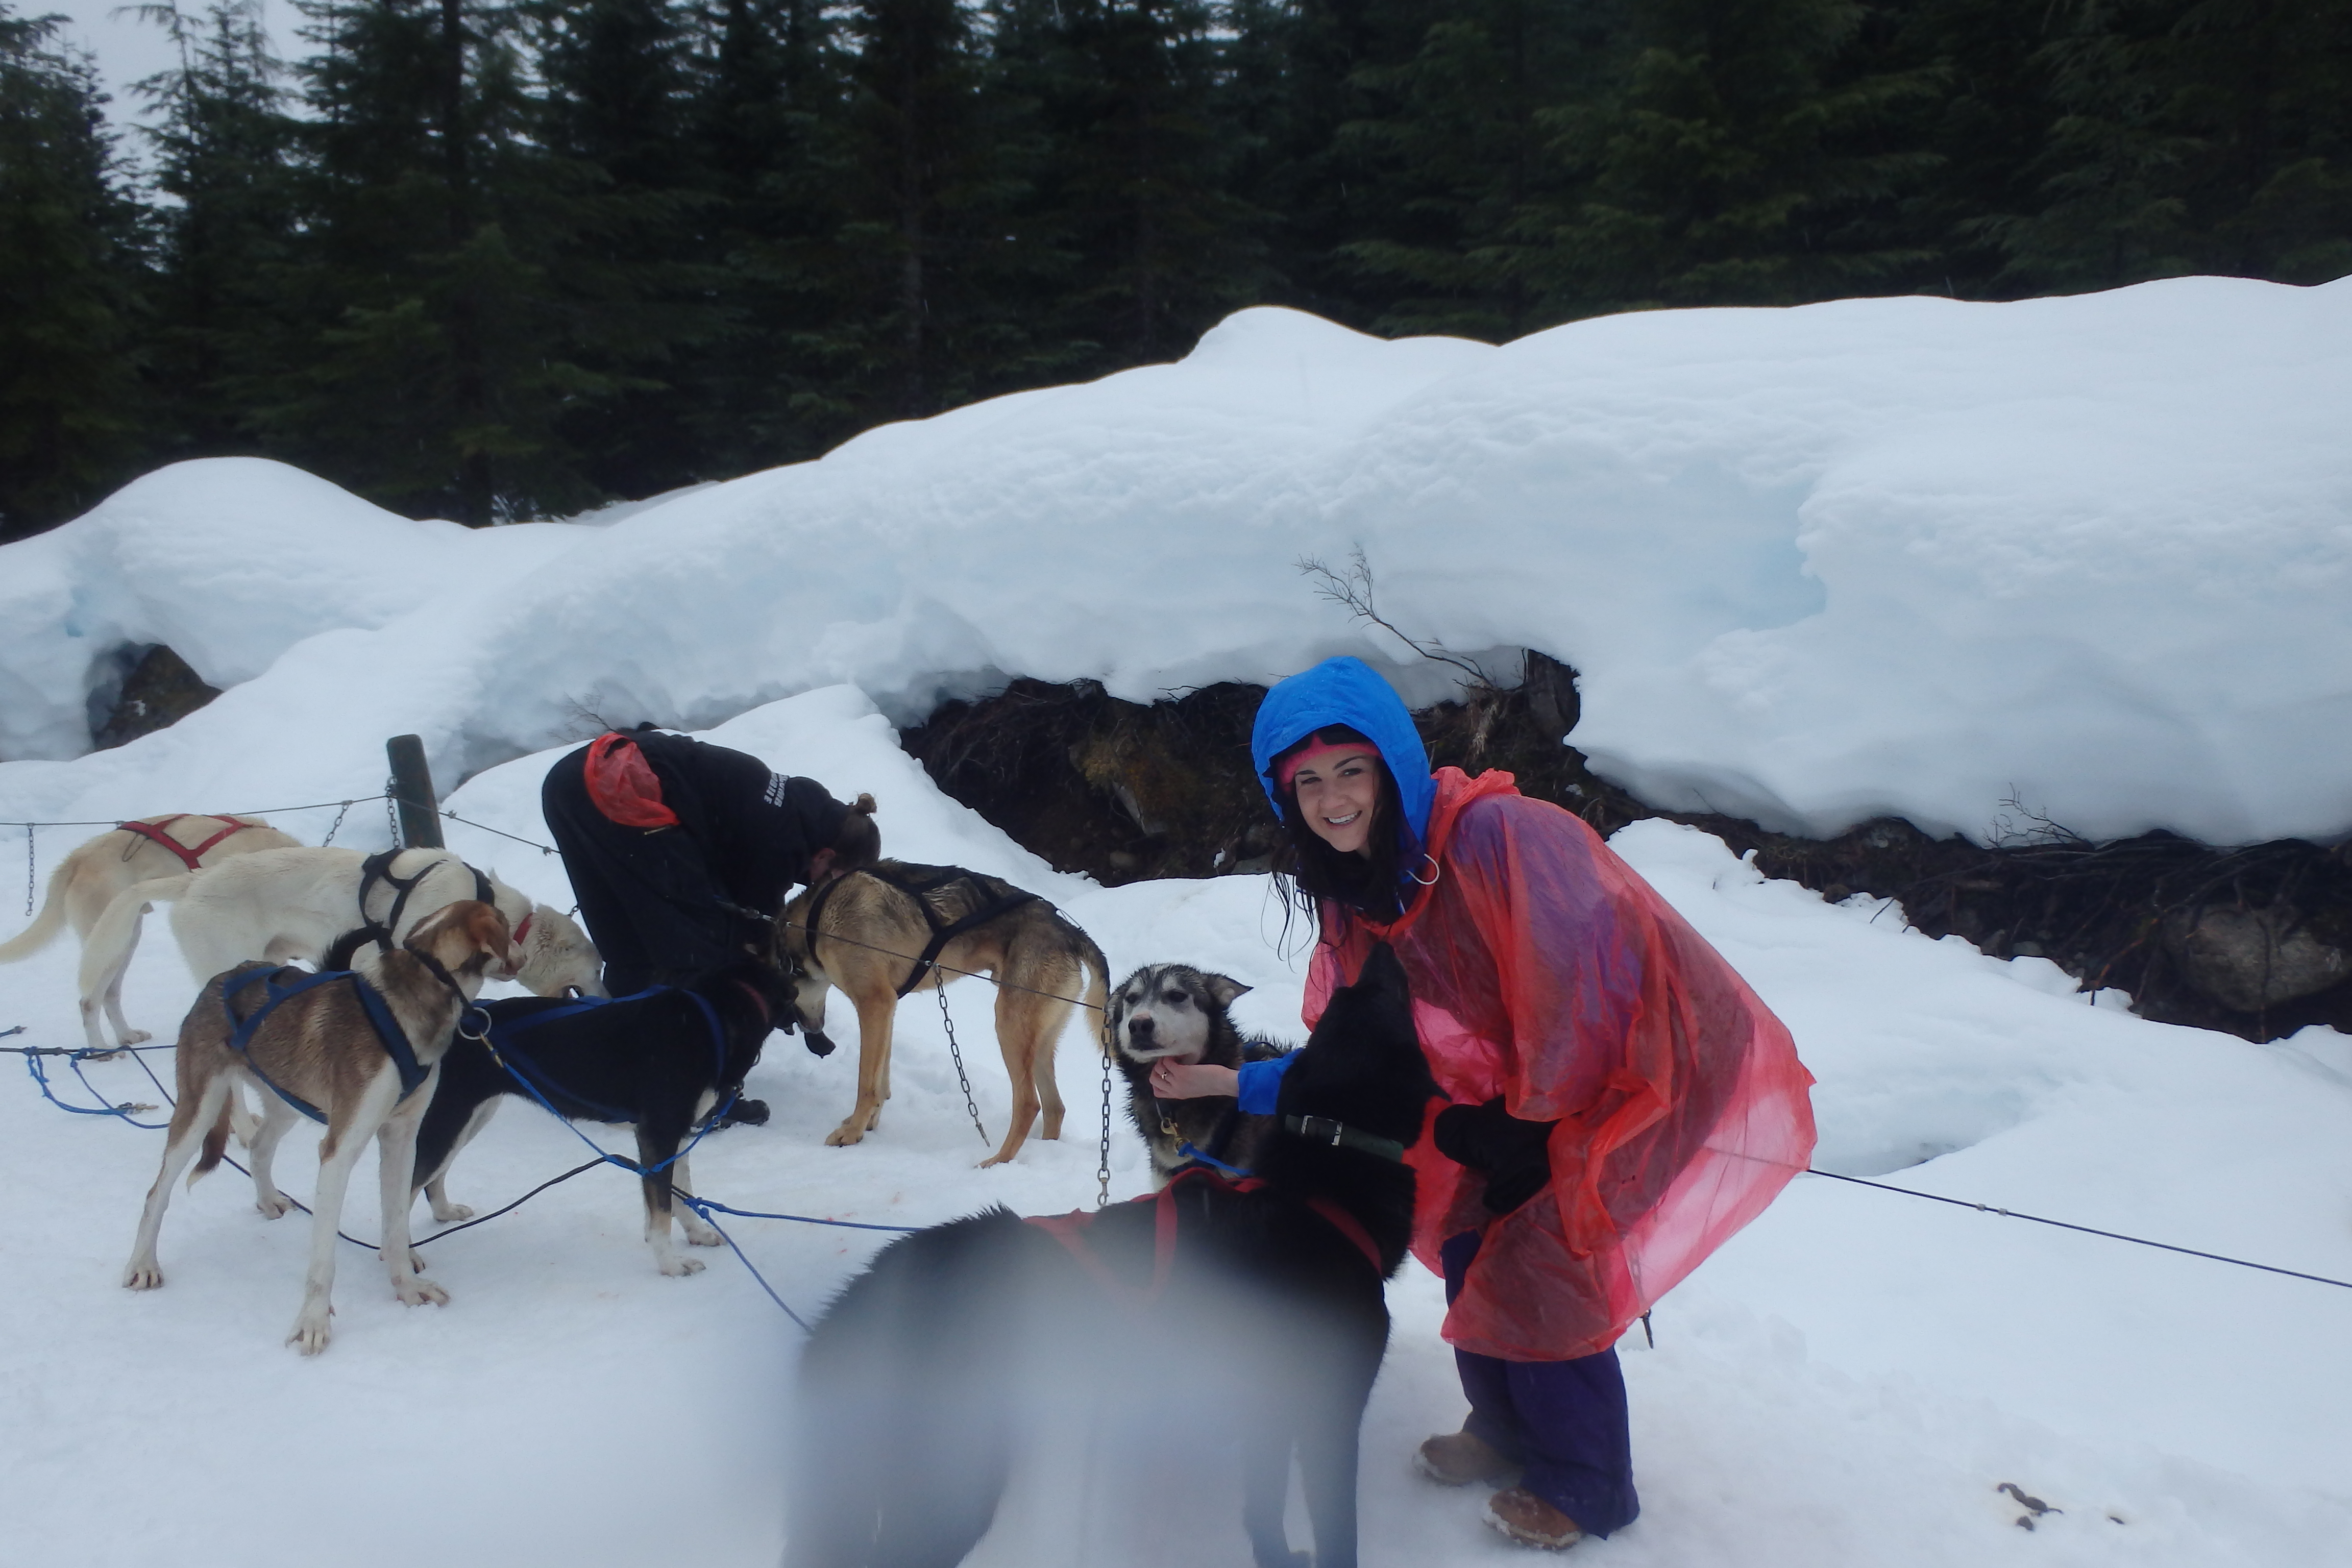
[1108,964,1287,1185]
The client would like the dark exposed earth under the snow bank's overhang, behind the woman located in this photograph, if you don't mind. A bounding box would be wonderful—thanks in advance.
[901,653,2352,1039]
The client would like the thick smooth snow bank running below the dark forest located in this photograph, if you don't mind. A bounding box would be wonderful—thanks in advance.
[0,277,2352,842]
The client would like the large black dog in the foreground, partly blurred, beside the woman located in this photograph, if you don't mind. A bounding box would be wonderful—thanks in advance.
[786,947,1437,1568]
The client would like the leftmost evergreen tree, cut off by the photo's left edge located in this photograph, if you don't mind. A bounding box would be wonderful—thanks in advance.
[0,0,143,538]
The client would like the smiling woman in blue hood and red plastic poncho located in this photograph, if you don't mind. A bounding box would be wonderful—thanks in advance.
[1153,658,1814,1547]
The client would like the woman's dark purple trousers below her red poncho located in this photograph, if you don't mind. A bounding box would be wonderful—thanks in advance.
[1439,1230,1641,1535]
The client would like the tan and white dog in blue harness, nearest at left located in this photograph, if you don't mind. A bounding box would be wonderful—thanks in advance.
[122,898,522,1356]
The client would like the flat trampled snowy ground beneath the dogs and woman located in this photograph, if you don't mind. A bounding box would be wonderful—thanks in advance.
[0,689,2352,1568]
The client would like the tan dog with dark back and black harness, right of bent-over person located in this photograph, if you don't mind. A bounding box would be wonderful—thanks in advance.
[776,861,1110,1166]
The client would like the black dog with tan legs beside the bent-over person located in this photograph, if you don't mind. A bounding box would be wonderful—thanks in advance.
[411,959,793,1274]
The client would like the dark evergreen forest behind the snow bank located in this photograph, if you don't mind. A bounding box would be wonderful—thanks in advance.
[0,0,2352,538]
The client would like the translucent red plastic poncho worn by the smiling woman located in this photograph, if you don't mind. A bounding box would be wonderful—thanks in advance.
[1305,769,1814,1361]
